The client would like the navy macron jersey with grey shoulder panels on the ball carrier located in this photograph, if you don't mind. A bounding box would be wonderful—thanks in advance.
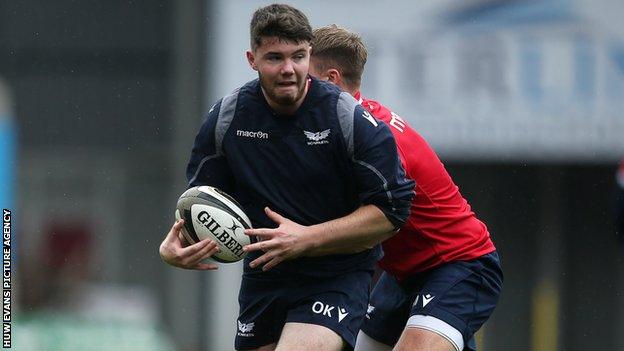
[186,78,414,275]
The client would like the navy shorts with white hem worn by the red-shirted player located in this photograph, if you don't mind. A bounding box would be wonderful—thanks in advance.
[362,252,503,350]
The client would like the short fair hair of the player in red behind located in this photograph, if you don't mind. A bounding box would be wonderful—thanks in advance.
[312,24,368,89]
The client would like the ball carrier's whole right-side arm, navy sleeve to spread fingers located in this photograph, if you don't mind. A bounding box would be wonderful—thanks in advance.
[244,105,414,270]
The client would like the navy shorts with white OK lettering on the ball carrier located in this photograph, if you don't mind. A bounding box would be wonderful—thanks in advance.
[235,270,372,350]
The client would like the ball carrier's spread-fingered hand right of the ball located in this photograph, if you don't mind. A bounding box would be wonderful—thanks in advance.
[243,207,308,271]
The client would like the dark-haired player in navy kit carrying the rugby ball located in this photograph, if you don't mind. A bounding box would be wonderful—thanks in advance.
[160,4,414,351]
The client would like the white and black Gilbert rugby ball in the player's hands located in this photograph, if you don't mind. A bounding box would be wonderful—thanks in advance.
[175,186,251,263]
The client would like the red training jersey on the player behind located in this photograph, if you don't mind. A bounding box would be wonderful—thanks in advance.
[355,92,496,280]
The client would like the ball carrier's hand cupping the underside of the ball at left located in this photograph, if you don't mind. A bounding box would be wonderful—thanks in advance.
[159,219,219,271]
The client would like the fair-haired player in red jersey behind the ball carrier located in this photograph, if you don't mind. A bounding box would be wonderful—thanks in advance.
[310,25,503,351]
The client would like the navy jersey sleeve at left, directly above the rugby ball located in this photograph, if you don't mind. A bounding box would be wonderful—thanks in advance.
[186,101,232,192]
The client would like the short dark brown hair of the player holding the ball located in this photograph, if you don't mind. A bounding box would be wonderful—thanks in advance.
[249,4,312,50]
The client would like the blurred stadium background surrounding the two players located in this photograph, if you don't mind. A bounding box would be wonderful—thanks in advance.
[0,0,624,351]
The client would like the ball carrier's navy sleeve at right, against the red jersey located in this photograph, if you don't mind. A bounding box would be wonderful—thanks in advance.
[353,104,415,229]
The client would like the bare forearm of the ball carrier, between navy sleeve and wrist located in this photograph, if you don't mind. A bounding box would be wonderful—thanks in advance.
[305,205,395,256]
